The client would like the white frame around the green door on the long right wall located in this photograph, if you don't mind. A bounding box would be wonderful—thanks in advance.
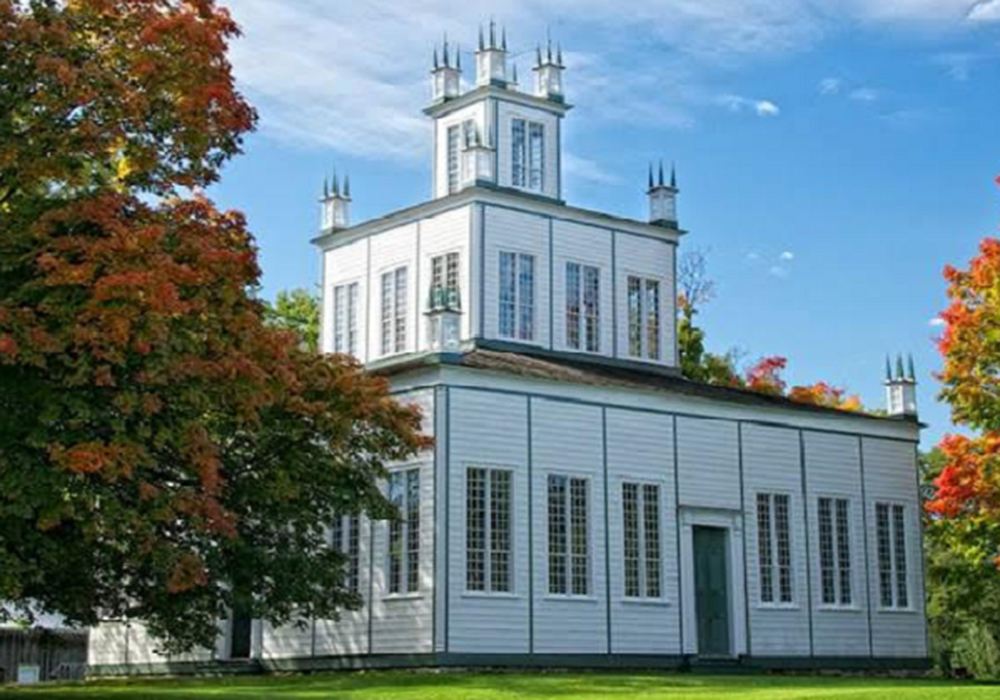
[680,507,747,657]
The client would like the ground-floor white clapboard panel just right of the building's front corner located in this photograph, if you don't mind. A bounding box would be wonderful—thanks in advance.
[448,389,529,653]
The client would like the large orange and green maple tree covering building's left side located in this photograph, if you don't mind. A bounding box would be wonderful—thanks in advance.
[0,0,428,651]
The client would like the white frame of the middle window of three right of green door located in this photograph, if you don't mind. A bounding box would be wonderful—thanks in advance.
[816,494,858,610]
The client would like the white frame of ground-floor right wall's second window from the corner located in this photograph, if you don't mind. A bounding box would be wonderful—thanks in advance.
[545,471,595,600]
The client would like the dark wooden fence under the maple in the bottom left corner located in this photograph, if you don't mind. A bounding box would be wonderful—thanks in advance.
[0,629,87,683]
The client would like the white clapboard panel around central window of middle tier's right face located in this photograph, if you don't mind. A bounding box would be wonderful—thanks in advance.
[552,220,614,356]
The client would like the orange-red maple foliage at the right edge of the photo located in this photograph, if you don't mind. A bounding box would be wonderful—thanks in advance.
[927,183,1000,567]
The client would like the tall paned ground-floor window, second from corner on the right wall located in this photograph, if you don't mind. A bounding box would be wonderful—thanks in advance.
[549,474,590,595]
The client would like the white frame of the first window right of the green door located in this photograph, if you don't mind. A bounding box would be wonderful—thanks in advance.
[754,491,799,609]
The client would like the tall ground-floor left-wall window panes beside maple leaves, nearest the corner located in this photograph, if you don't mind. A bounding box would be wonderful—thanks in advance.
[389,469,420,593]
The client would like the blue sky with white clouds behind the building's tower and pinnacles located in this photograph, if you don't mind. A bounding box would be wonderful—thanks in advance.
[212,0,1000,444]
